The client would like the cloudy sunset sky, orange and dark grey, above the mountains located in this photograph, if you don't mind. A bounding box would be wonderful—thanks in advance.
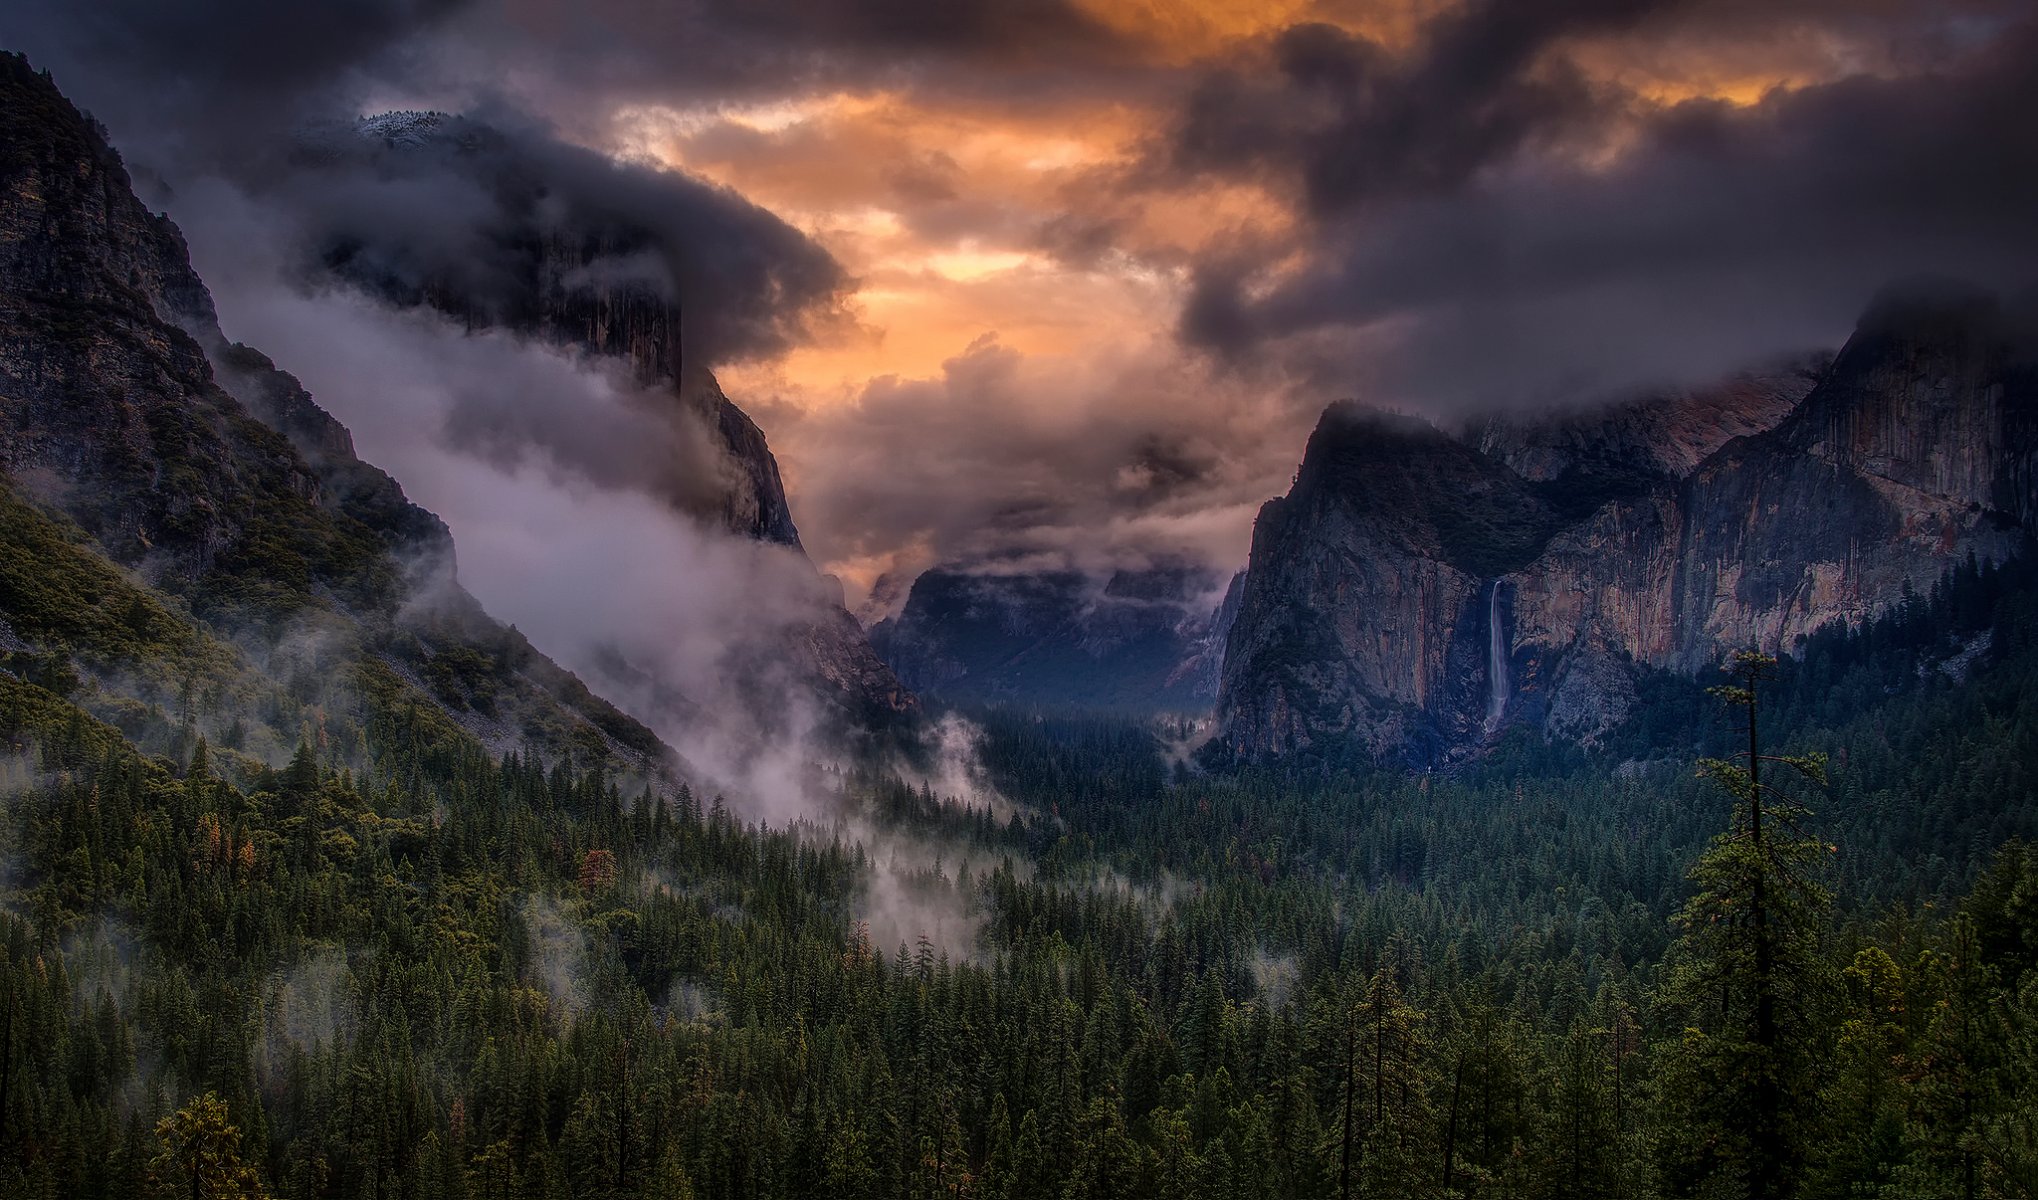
[0,0,2038,603]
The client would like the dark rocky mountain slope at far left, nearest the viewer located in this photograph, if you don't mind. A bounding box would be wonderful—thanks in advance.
[0,55,675,776]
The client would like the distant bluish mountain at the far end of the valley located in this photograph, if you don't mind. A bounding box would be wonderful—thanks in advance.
[870,562,1237,713]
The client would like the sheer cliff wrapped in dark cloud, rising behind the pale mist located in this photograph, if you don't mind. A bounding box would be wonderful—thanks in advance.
[293,112,915,723]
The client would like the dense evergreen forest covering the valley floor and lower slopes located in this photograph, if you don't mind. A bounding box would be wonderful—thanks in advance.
[0,537,2038,1198]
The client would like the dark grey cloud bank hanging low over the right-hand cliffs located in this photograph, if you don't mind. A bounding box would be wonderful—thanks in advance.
[1180,12,2038,407]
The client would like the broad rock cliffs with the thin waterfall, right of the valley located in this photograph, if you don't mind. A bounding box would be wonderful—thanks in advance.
[1217,281,2038,764]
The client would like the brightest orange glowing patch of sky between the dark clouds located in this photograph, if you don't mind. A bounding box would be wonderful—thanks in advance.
[615,94,1230,399]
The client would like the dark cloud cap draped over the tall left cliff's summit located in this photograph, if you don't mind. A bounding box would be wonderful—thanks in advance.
[285,114,848,369]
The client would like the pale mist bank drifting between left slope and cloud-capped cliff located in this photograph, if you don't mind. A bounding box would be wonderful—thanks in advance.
[169,183,860,817]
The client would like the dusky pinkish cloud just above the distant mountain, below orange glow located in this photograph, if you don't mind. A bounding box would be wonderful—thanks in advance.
[749,334,1308,585]
